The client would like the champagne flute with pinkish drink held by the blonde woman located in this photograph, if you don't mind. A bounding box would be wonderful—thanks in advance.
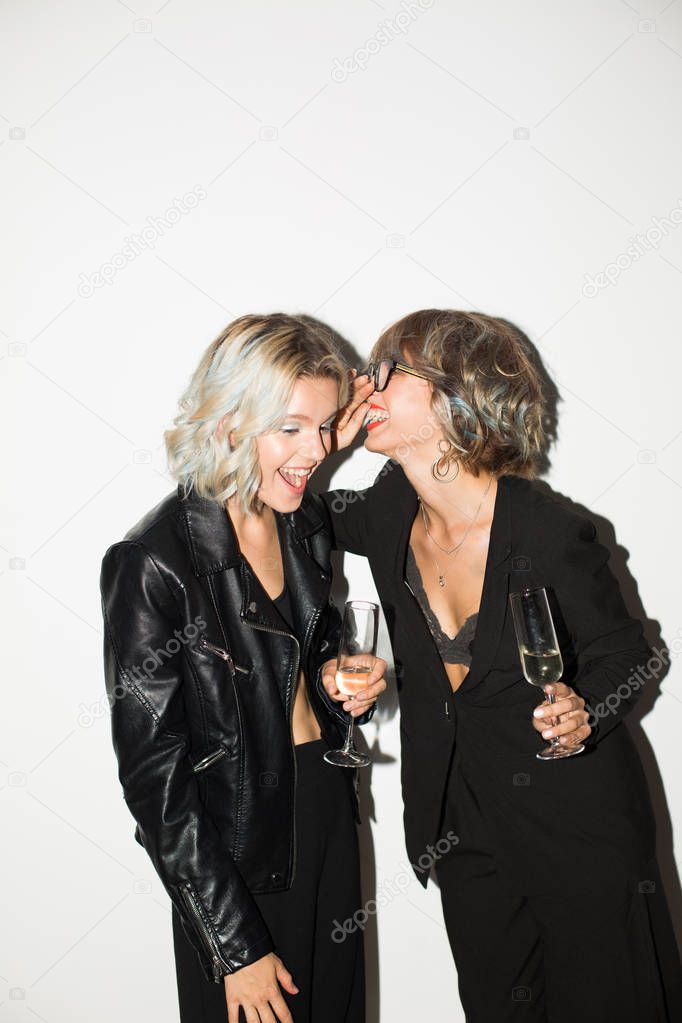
[324,601,379,767]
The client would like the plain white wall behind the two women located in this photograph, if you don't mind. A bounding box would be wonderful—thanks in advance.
[0,0,682,1023]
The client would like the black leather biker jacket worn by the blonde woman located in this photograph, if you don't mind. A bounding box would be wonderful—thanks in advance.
[100,486,374,983]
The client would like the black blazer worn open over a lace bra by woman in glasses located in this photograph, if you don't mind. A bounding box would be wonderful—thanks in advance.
[321,459,654,893]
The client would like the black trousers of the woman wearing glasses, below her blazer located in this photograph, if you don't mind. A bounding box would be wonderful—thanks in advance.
[436,762,682,1023]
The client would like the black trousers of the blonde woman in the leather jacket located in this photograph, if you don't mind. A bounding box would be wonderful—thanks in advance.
[173,739,365,1023]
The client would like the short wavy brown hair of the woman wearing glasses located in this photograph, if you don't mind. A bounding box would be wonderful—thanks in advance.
[370,309,547,479]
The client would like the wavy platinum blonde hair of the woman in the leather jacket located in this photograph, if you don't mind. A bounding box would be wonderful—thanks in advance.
[164,313,350,514]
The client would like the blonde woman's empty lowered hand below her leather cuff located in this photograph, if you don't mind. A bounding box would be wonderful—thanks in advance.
[224,952,299,1023]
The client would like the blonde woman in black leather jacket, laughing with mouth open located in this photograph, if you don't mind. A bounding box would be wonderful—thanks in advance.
[101,314,385,1023]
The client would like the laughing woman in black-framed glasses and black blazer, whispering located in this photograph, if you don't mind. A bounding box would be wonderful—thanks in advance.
[322,310,682,1023]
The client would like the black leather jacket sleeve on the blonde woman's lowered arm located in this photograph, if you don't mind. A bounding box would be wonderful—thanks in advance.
[100,540,274,983]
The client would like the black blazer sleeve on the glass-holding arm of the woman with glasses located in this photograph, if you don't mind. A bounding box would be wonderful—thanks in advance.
[554,516,653,744]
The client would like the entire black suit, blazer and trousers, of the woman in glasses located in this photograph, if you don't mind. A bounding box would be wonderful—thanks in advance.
[322,468,682,1010]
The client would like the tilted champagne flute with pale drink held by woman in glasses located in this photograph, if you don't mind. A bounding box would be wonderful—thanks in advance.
[509,586,585,760]
